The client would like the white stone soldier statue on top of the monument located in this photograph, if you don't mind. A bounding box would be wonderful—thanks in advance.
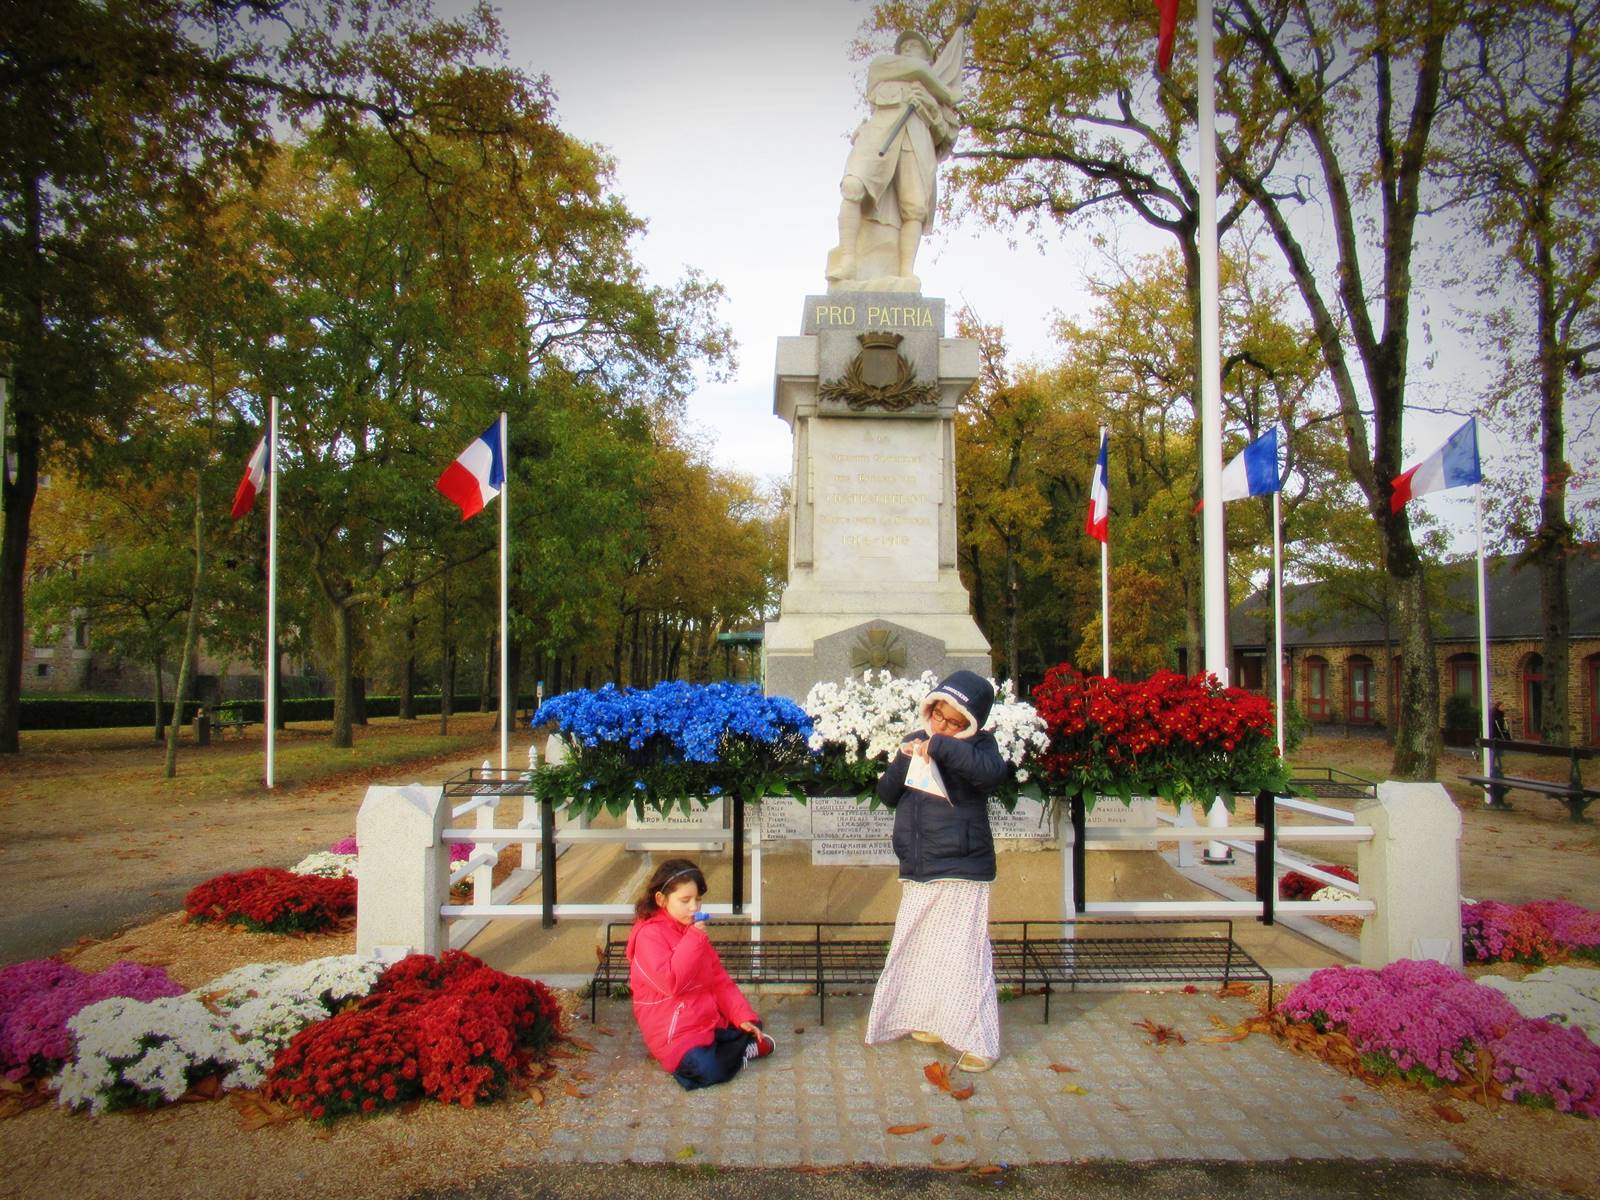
[827,22,966,291]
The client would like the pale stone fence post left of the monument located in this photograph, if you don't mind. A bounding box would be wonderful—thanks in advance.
[355,784,450,958]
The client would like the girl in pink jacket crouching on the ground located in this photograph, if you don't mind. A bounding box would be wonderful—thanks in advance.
[627,858,776,1090]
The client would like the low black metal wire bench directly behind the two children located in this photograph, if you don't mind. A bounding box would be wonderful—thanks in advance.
[589,918,1272,1024]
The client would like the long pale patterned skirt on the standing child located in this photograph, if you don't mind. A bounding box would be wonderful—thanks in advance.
[867,878,1000,1059]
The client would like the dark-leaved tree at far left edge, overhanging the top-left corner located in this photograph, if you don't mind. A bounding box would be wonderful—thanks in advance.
[0,0,595,754]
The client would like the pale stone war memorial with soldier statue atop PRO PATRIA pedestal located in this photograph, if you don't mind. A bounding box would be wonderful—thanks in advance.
[765,30,992,698]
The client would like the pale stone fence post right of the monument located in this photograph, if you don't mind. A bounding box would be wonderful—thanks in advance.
[1355,779,1461,968]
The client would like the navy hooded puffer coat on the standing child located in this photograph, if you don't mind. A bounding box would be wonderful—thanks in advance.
[878,670,1010,883]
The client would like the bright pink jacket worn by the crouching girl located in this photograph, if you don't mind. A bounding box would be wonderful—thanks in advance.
[627,910,760,1070]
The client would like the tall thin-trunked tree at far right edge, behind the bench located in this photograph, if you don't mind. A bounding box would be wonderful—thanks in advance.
[1437,0,1600,741]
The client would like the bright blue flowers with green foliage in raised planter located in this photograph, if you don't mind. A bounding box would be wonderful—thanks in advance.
[533,683,811,814]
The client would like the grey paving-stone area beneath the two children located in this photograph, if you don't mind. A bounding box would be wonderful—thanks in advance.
[506,992,1459,1166]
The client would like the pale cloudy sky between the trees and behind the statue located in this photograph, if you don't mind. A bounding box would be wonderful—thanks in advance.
[473,0,1600,549]
